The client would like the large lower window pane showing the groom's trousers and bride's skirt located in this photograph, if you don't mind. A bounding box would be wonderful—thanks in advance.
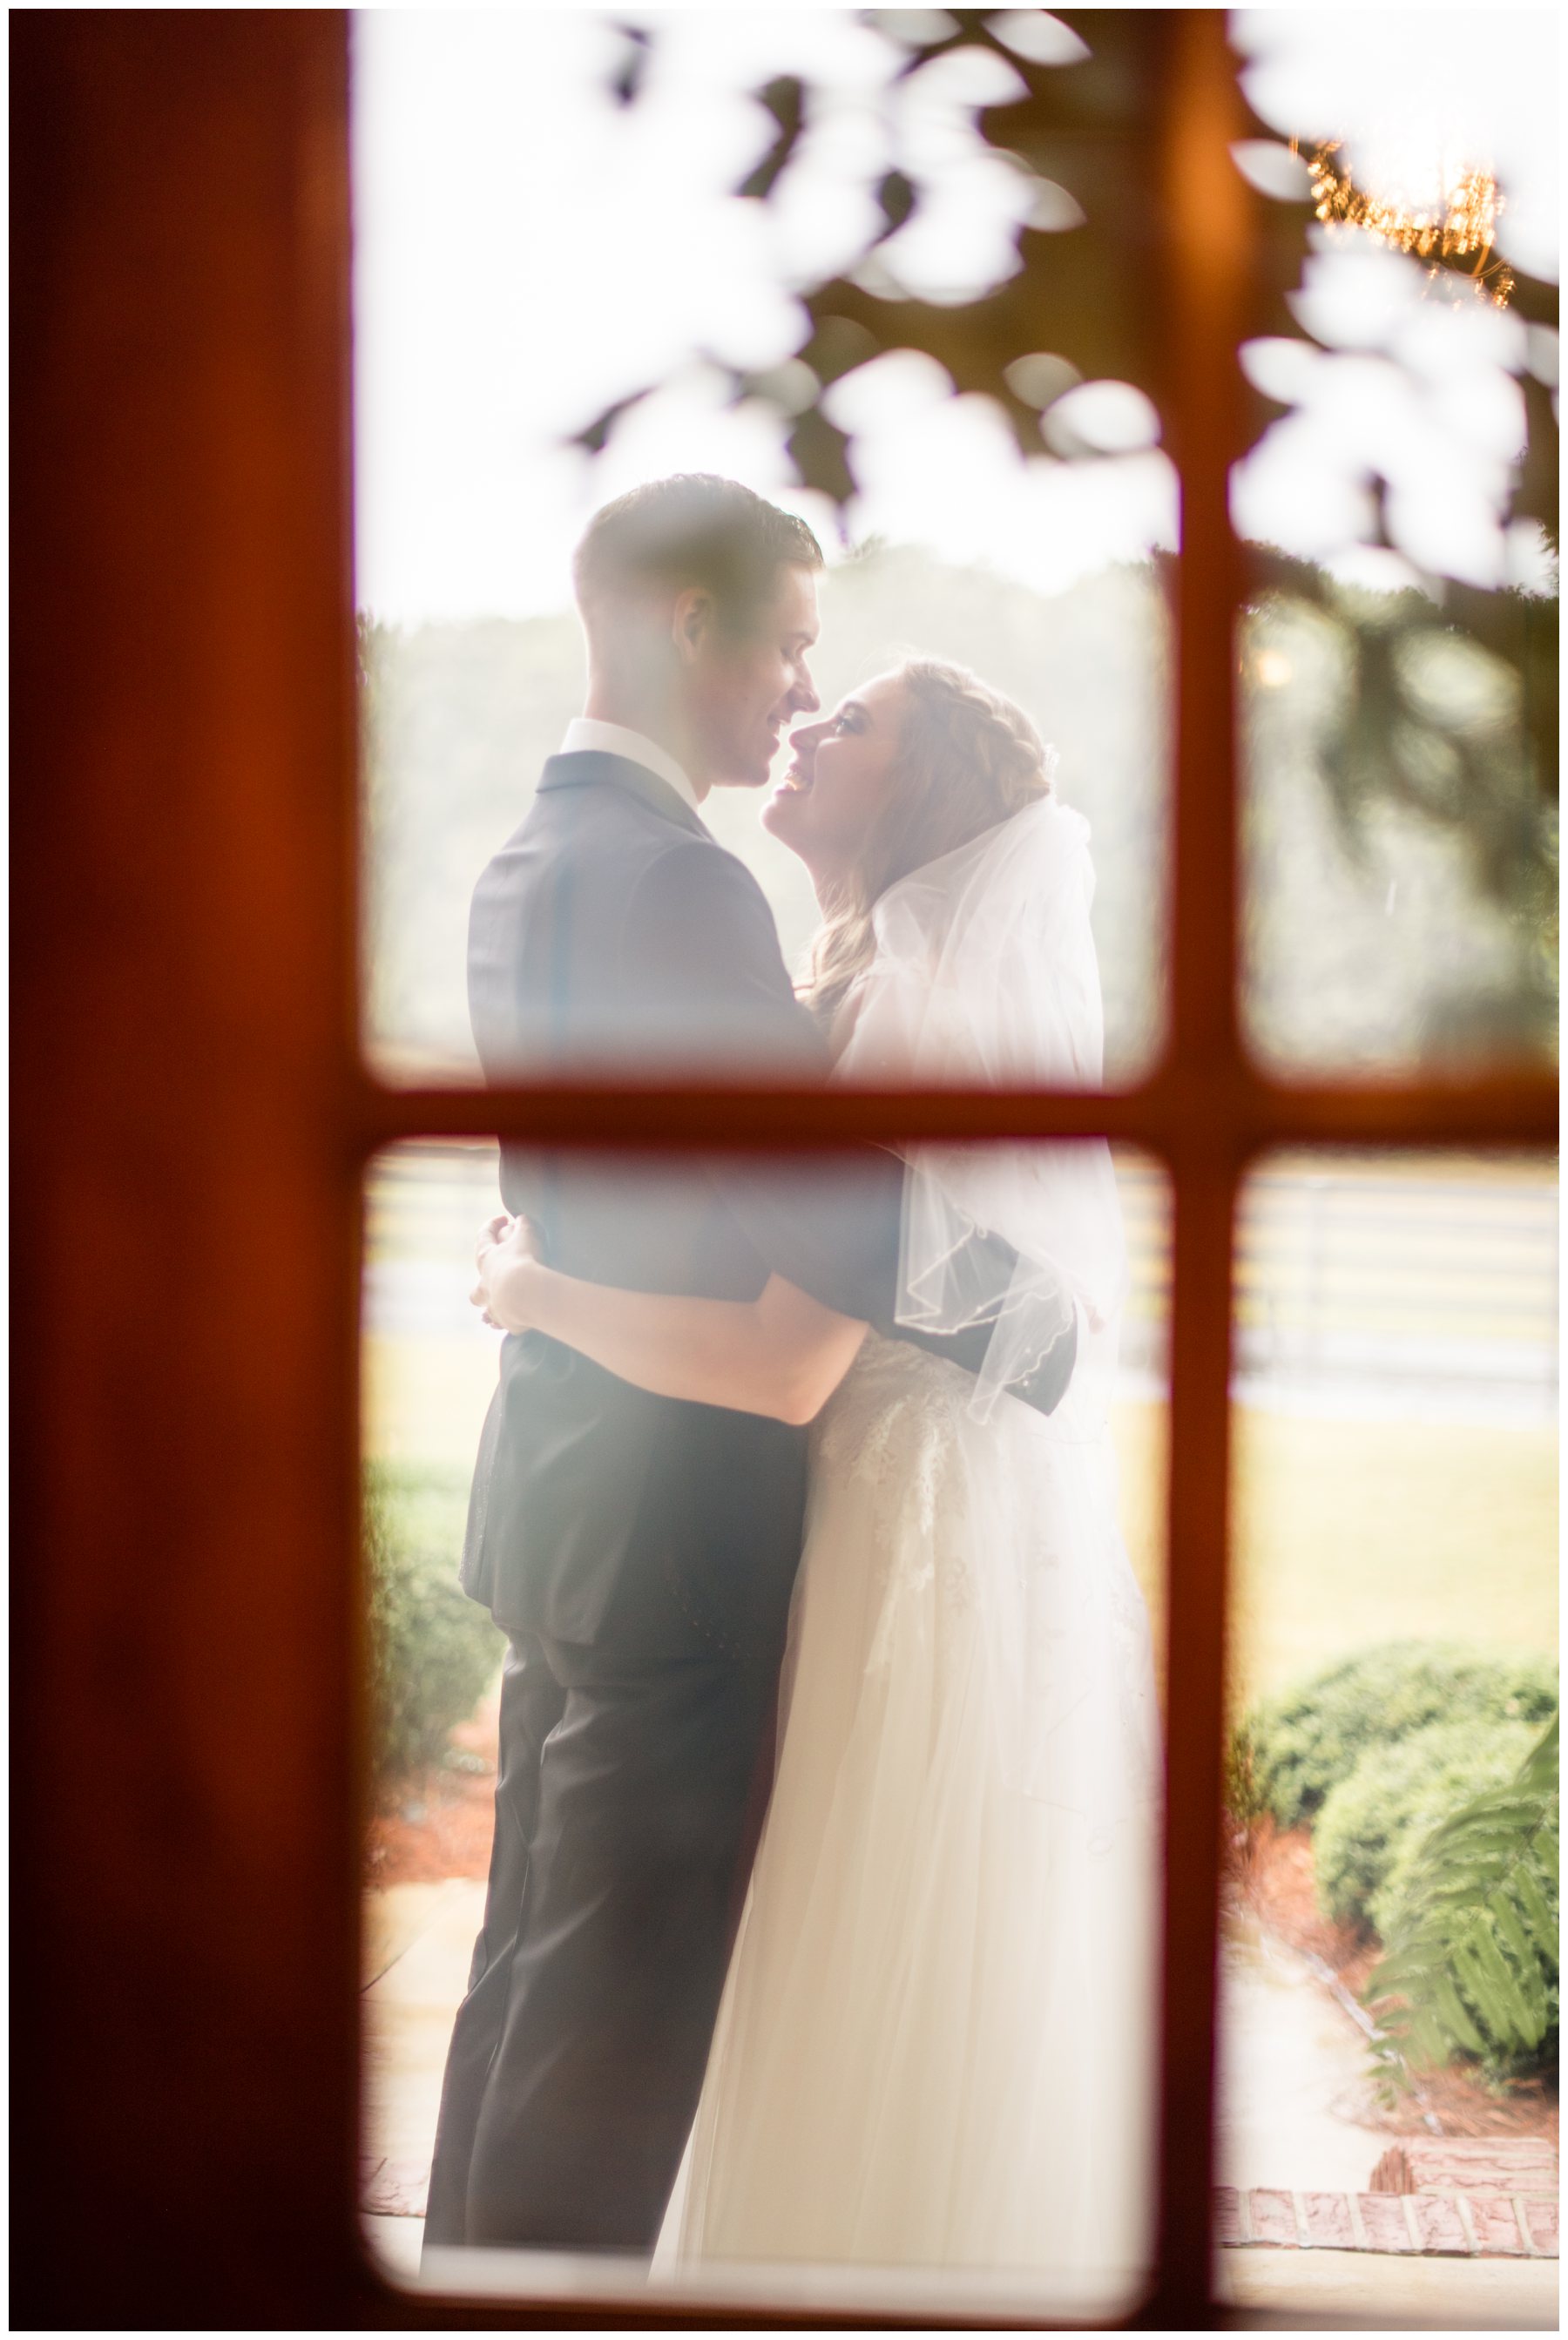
[362,1144,1168,2316]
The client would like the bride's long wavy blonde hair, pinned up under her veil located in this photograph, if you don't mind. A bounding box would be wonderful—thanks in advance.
[801,658,1056,1023]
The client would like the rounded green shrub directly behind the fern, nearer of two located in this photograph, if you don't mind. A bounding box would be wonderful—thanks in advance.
[1313,1720,1538,1933]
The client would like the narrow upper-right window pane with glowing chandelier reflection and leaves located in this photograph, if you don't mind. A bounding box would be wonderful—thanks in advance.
[1233,10,1558,1077]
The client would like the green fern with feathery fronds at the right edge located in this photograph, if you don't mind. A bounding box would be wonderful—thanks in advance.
[1364,1715,1558,2087]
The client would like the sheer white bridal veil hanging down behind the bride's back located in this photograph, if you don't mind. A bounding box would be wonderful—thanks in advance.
[838,795,1153,1839]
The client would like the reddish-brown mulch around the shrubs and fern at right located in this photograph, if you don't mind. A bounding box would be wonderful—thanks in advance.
[1227,1818,1557,2146]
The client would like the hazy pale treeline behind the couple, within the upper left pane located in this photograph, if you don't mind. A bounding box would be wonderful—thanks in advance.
[362,548,1166,1085]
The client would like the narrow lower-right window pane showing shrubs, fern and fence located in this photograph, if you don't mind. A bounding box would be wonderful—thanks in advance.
[1220,1153,1557,2326]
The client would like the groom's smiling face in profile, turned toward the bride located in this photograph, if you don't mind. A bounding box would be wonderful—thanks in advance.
[679,562,821,788]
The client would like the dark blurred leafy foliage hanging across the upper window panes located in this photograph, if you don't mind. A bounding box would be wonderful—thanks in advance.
[590,10,1558,1053]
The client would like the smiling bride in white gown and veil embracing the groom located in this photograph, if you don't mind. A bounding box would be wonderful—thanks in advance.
[475,659,1159,2305]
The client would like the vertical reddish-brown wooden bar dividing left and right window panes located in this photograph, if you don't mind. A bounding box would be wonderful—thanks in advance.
[1156,10,1257,2326]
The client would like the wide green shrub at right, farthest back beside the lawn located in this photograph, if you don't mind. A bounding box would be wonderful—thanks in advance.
[1231,1640,1557,1828]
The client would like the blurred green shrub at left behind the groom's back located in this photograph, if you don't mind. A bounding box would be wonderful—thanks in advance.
[365,1464,505,1790]
